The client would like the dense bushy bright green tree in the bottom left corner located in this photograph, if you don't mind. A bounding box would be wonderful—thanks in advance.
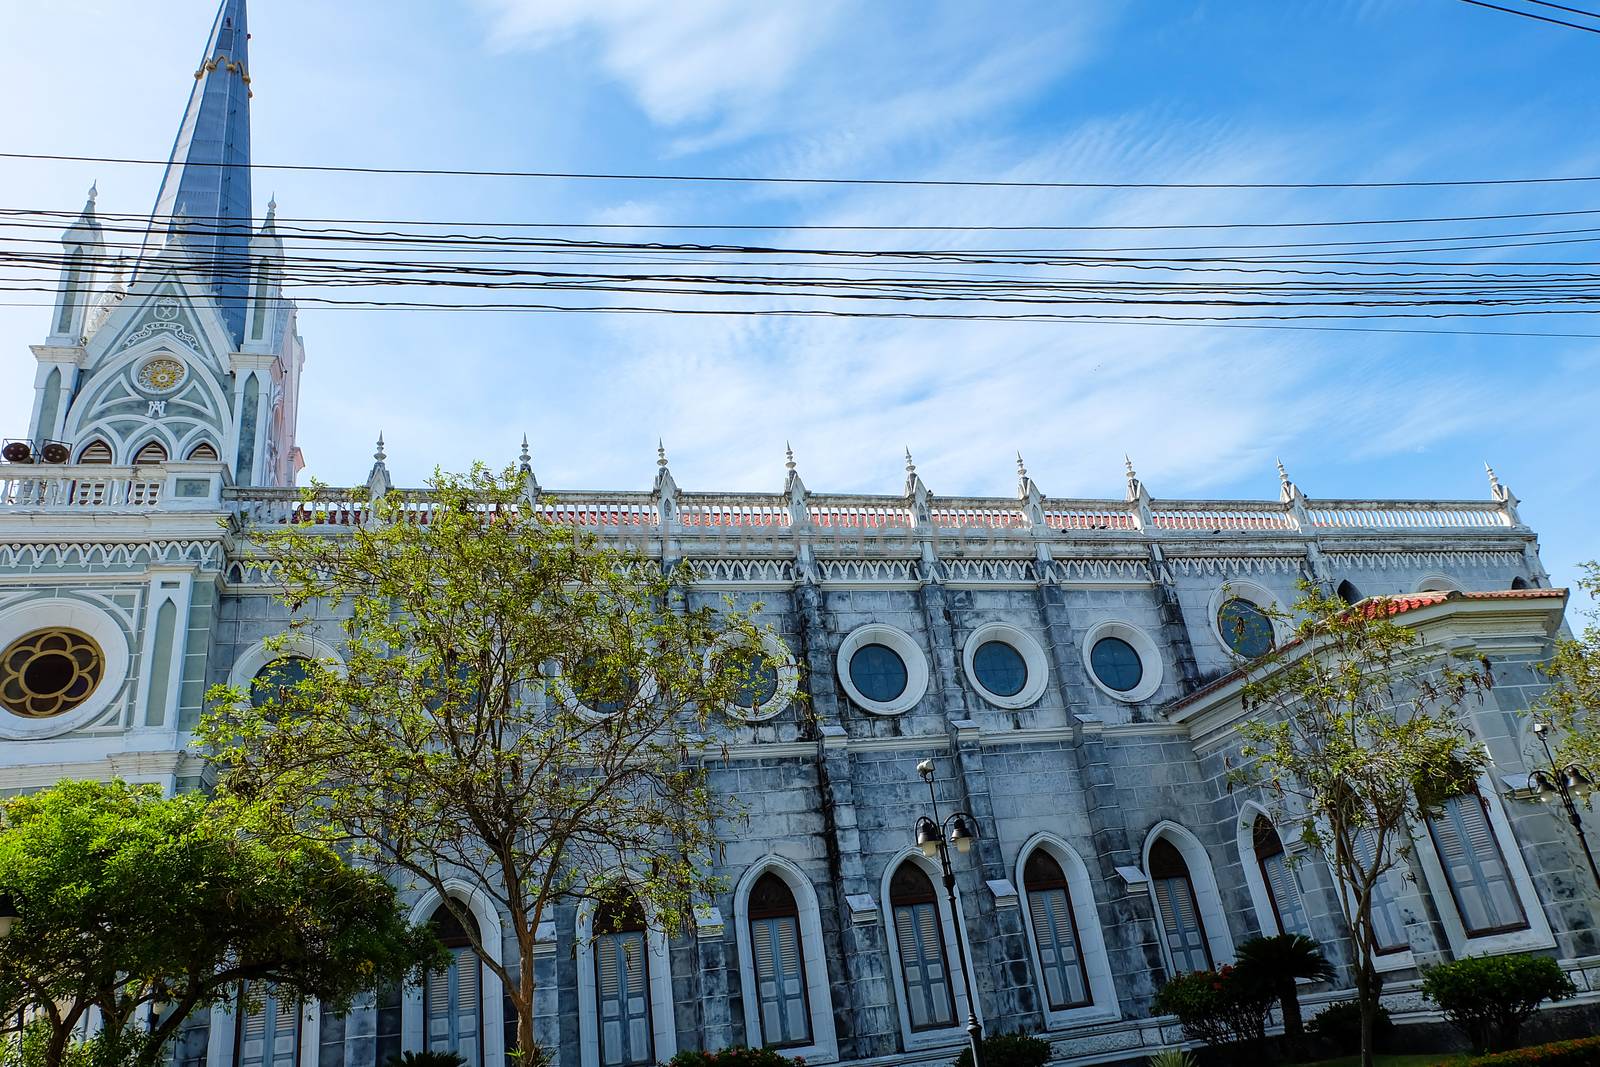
[0,781,442,1067]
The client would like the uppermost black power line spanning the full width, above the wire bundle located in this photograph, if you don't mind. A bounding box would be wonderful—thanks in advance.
[0,149,1600,189]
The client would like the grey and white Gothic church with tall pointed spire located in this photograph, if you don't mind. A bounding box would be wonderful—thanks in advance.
[0,0,1600,1067]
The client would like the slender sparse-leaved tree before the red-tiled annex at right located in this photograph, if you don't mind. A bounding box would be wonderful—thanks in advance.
[1230,582,1491,1067]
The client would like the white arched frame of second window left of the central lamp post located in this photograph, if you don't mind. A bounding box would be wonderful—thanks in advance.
[733,856,838,1064]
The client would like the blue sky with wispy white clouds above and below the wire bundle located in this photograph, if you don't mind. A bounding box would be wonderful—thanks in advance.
[0,0,1600,601]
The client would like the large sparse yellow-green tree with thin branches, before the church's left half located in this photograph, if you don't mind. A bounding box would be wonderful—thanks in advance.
[200,466,774,1049]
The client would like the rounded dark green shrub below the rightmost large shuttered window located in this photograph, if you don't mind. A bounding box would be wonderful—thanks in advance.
[1422,955,1578,1053]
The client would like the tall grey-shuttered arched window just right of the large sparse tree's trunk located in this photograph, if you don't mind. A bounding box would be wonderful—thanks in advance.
[594,897,654,1067]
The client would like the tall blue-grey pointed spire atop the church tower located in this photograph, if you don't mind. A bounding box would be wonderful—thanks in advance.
[141,0,251,346]
